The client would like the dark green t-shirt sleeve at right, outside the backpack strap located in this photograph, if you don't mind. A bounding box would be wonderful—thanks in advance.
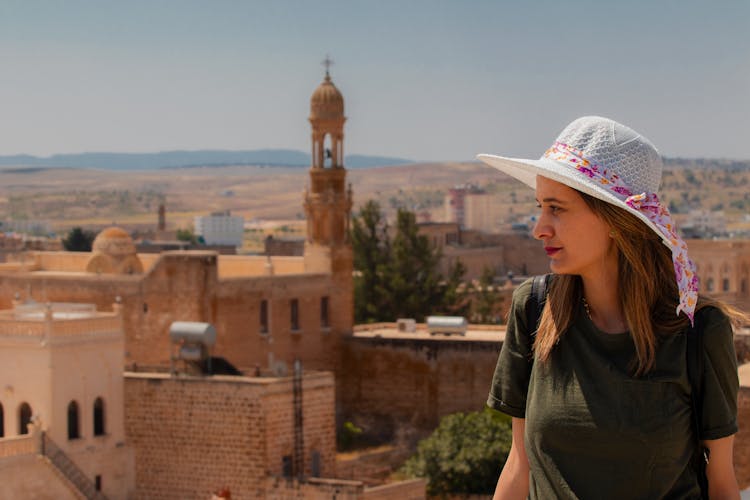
[699,307,739,439]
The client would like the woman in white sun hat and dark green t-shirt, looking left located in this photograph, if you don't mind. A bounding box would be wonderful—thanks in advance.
[478,117,747,499]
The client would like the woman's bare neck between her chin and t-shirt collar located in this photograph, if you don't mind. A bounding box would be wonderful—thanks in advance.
[581,273,628,333]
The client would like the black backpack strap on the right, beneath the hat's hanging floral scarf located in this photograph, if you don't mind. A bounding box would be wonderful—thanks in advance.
[687,313,708,499]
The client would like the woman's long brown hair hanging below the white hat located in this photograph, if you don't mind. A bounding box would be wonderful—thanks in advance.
[534,192,747,376]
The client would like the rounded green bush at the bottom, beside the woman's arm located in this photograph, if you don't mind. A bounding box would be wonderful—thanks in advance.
[401,408,512,496]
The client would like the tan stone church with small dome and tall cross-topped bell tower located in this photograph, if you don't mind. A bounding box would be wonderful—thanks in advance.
[0,73,353,382]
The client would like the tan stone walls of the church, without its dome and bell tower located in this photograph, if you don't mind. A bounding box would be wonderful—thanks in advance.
[0,251,353,370]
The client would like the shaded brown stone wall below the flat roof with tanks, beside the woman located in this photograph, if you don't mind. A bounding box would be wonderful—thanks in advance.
[339,337,501,430]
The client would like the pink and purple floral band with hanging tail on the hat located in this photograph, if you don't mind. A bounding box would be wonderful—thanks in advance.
[544,142,698,324]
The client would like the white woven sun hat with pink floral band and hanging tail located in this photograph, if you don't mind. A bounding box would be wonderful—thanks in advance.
[477,116,698,321]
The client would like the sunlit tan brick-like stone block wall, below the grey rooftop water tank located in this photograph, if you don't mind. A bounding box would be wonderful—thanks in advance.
[125,372,336,499]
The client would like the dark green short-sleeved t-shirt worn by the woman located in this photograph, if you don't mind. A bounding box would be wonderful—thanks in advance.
[487,280,739,500]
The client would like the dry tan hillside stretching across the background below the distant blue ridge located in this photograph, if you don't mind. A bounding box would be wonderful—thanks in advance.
[0,162,750,236]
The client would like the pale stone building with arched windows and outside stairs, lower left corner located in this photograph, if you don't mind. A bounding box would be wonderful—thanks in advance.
[0,303,135,499]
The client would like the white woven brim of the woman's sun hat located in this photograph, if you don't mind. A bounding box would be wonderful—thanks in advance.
[477,154,680,246]
